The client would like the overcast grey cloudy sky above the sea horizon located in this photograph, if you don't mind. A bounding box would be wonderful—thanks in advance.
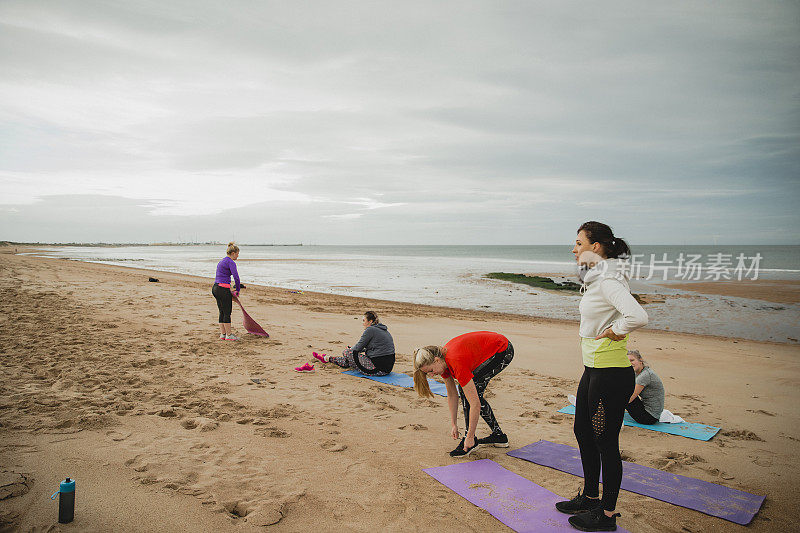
[0,0,800,244]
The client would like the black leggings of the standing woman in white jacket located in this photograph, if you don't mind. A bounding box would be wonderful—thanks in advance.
[575,366,636,511]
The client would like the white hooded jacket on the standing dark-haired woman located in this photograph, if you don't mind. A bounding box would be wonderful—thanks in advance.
[578,259,647,339]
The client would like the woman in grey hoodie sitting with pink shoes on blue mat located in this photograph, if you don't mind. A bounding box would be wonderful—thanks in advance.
[314,311,394,376]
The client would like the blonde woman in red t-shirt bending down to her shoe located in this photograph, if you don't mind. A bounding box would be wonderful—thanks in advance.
[414,331,514,457]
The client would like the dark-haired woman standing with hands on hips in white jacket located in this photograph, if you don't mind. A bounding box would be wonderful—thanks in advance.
[556,222,647,531]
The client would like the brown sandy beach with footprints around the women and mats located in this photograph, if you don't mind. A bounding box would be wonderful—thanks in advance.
[0,249,800,532]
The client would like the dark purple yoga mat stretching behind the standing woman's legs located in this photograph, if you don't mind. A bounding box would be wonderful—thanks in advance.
[508,440,764,525]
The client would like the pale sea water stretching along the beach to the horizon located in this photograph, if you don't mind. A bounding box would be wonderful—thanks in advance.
[26,245,800,343]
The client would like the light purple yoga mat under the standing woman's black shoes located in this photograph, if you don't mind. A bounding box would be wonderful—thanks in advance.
[423,459,625,533]
